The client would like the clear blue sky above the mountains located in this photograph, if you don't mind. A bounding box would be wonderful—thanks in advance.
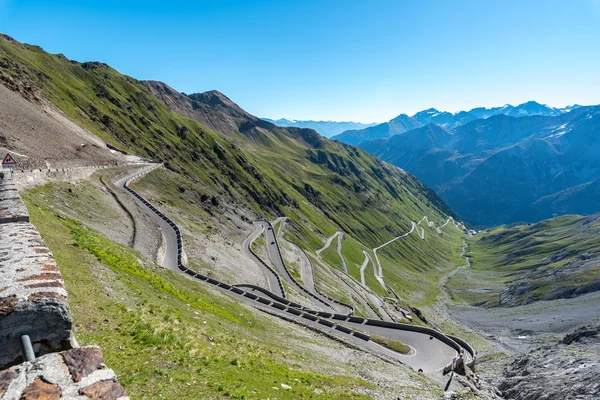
[0,0,600,122]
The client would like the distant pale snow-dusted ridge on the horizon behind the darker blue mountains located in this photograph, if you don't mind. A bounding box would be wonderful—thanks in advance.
[332,101,580,146]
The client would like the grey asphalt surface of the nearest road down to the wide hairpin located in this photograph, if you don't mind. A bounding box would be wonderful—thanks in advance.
[116,164,464,371]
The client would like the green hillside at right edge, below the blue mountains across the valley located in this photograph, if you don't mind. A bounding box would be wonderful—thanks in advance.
[448,215,600,306]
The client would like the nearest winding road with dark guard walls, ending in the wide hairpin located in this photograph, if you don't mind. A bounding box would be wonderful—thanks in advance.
[115,164,472,371]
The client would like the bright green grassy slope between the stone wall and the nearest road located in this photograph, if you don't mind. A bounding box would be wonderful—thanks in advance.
[24,186,378,399]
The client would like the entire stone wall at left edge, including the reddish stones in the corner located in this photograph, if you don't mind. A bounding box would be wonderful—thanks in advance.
[0,176,125,400]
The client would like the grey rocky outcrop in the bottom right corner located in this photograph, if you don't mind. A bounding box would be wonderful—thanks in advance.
[498,325,600,400]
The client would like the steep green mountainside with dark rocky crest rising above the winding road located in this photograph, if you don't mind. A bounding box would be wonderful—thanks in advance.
[0,30,454,260]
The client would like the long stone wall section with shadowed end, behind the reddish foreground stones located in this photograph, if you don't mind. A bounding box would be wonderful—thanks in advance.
[0,183,73,368]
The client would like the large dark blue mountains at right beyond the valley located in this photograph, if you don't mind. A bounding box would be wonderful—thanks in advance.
[360,108,600,226]
